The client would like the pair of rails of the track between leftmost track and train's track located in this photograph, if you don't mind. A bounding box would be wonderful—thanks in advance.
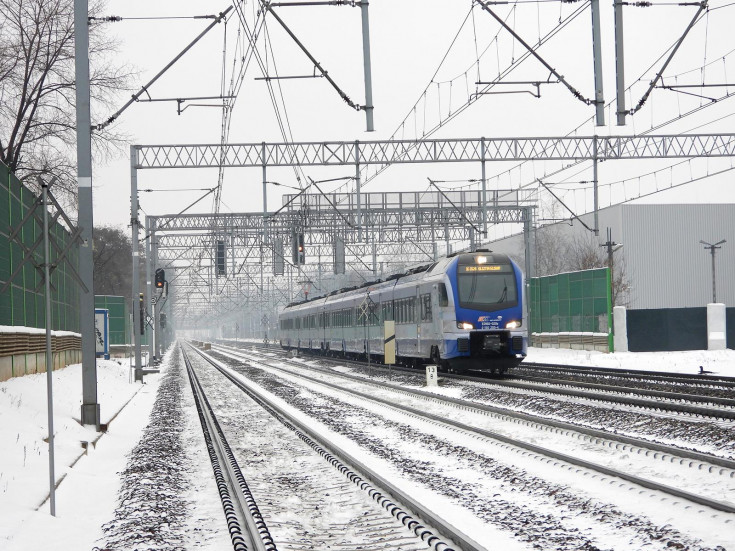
[211,342,735,513]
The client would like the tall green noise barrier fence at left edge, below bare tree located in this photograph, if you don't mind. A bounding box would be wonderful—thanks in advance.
[0,163,80,332]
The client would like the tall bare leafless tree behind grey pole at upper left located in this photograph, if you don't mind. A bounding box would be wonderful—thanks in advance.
[0,0,132,215]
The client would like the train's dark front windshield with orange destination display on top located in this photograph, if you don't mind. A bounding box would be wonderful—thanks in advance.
[457,264,518,312]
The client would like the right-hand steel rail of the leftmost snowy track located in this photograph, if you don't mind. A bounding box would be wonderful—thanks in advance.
[187,349,489,551]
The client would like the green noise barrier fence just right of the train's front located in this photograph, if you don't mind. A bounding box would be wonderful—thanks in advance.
[530,268,613,350]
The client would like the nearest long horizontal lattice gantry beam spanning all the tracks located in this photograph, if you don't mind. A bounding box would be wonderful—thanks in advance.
[133,134,735,169]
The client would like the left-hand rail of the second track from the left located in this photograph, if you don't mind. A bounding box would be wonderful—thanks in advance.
[210,344,735,513]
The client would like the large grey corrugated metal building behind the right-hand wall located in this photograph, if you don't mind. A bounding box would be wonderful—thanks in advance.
[490,204,735,310]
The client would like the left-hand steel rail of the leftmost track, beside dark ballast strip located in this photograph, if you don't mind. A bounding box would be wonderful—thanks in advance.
[181,346,277,551]
